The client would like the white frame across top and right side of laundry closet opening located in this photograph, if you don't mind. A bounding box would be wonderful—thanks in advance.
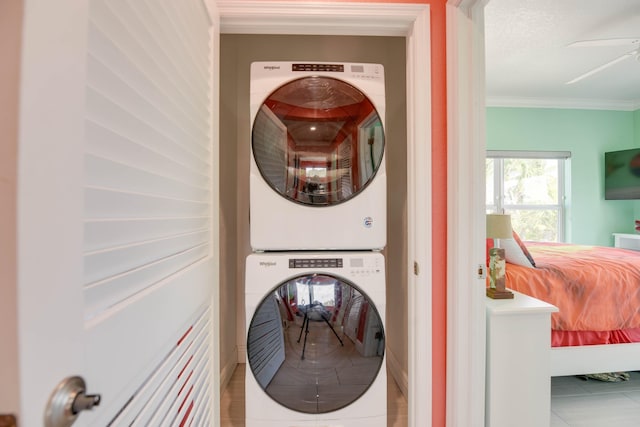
[217,0,432,425]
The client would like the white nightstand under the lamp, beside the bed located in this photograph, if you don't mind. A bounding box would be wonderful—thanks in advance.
[485,291,558,427]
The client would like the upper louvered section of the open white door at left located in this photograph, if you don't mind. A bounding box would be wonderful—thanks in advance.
[84,1,212,316]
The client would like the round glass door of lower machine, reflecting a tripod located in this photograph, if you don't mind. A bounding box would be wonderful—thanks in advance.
[247,274,385,414]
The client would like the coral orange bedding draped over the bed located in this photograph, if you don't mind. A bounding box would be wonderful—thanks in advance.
[506,242,640,347]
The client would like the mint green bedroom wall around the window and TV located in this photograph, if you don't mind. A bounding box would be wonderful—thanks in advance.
[486,107,640,246]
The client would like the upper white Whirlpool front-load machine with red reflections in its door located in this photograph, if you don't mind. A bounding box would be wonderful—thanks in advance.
[250,62,387,251]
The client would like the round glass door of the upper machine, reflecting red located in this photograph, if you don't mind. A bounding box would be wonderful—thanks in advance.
[251,76,384,206]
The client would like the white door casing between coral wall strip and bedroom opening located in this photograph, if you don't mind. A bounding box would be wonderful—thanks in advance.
[446,0,486,427]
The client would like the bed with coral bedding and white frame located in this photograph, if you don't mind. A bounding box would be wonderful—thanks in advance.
[506,241,640,376]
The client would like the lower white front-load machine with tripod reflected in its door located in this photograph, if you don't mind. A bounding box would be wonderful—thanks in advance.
[245,252,387,427]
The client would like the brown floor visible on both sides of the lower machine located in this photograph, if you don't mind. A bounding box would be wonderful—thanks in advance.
[220,365,407,427]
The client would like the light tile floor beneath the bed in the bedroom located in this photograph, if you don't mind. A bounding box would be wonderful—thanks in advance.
[551,372,640,427]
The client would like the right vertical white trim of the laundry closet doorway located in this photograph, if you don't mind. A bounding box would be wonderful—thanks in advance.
[407,8,433,426]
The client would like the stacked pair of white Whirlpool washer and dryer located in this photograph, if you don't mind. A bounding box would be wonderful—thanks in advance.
[245,62,387,427]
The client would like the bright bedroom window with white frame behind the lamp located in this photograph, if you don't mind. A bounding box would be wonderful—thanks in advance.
[486,151,571,242]
